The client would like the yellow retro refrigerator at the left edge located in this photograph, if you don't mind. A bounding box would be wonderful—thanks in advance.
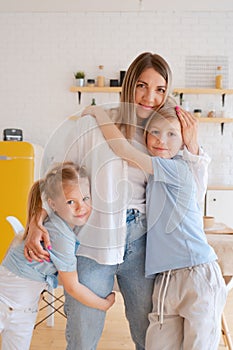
[0,141,34,262]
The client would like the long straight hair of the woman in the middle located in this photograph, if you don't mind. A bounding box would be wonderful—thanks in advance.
[119,52,172,139]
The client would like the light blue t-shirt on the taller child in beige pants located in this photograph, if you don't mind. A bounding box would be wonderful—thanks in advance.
[146,156,217,277]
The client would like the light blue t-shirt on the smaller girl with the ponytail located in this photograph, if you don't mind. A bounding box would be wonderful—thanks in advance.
[2,213,79,288]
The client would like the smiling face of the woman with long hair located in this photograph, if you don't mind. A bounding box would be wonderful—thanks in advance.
[135,68,167,119]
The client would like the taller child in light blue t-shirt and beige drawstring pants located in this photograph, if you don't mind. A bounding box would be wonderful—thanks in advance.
[87,101,226,350]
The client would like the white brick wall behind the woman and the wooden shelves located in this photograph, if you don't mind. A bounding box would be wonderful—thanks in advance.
[0,9,233,185]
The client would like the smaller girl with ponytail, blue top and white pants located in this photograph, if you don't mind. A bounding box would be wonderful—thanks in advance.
[0,162,114,350]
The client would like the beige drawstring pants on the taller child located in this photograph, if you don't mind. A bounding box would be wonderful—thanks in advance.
[146,261,227,350]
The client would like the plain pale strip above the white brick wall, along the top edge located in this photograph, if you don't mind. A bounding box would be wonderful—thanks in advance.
[0,0,233,12]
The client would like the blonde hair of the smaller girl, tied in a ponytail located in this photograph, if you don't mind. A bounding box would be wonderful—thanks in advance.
[23,162,88,239]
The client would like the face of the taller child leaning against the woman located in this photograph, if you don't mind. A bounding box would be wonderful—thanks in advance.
[146,116,183,159]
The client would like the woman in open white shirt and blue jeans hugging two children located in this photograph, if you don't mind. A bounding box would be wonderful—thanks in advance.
[25,52,208,350]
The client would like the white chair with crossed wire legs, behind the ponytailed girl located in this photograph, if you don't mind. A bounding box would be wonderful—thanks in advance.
[6,216,66,328]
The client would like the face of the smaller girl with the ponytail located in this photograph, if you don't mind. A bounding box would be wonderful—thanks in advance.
[48,178,92,228]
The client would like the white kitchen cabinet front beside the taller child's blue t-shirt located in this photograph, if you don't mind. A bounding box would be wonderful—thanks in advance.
[205,187,233,228]
